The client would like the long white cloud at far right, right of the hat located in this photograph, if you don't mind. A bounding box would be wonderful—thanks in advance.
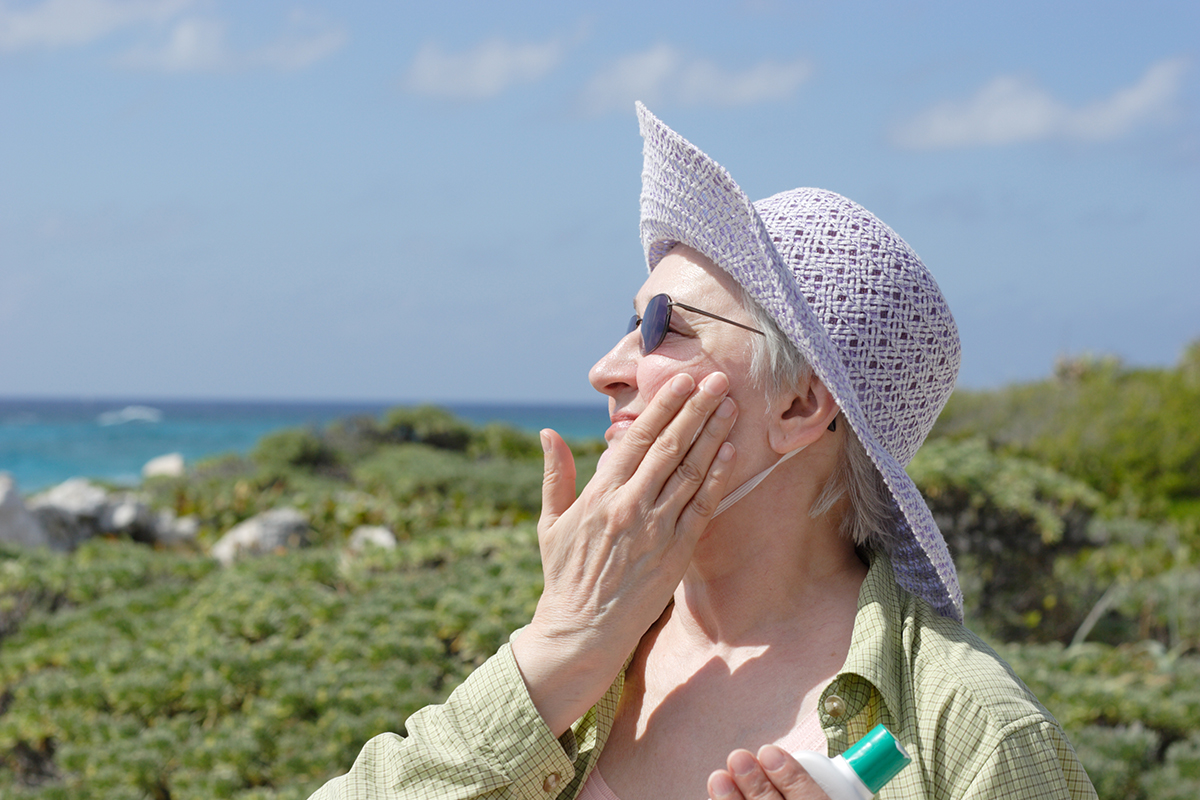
[893,59,1188,150]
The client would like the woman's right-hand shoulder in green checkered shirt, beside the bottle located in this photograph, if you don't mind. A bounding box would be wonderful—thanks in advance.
[851,558,1086,796]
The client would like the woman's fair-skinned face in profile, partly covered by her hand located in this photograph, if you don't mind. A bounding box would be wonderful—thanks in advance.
[588,245,778,486]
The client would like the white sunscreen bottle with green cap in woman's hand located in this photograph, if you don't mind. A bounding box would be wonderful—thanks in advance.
[792,724,912,800]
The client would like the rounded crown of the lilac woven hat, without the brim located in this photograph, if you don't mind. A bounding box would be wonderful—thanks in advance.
[754,188,961,464]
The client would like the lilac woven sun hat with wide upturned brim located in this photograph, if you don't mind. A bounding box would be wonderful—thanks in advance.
[637,103,962,621]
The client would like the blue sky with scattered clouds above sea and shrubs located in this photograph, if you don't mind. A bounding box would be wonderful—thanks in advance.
[0,0,1200,402]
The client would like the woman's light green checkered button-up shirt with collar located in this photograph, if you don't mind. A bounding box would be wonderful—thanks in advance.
[313,557,1096,800]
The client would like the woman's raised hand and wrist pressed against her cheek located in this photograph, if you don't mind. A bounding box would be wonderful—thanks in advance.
[512,372,737,735]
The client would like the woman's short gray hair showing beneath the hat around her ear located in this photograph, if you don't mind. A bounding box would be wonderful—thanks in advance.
[739,287,895,549]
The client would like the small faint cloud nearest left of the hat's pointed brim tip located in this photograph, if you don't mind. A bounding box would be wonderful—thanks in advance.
[403,38,566,100]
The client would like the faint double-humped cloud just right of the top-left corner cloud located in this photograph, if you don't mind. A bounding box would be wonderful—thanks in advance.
[116,14,347,72]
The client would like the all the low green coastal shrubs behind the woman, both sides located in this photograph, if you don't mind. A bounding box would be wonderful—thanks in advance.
[0,343,1200,800]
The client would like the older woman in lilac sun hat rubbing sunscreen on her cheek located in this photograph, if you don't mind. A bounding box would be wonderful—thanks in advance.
[304,106,1094,800]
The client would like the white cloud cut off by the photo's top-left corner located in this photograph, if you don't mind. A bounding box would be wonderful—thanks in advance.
[0,0,192,50]
